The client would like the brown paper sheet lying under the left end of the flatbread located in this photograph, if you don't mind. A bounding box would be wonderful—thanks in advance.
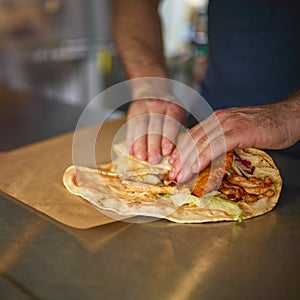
[0,118,124,229]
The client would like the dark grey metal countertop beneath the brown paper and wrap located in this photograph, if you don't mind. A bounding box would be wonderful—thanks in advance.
[0,85,300,300]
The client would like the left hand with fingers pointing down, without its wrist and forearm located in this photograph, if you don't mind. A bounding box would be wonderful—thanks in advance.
[127,99,186,164]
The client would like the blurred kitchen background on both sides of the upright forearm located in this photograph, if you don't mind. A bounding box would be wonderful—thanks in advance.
[0,0,208,106]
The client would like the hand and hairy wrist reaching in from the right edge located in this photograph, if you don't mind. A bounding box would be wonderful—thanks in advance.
[169,97,300,183]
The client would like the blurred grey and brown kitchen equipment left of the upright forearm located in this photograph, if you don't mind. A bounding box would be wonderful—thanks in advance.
[0,0,122,105]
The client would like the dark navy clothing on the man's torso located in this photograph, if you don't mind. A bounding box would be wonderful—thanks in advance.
[201,0,300,154]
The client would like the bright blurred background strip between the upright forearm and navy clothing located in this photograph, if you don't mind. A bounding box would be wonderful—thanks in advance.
[160,0,208,91]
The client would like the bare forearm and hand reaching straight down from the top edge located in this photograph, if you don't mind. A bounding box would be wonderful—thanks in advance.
[112,0,186,163]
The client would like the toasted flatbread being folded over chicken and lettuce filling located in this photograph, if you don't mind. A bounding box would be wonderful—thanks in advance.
[63,148,282,223]
